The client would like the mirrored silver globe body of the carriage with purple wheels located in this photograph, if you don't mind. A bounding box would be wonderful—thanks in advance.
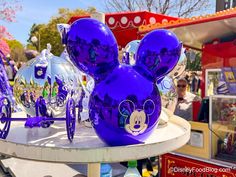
[13,52,82,117]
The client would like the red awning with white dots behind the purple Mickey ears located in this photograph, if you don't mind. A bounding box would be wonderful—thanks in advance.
[68,11,178,47]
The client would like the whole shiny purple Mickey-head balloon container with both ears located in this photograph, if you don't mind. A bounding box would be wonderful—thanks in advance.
[67,19,181,146]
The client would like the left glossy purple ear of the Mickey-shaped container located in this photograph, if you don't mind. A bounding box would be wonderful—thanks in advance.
[66,18,119,81]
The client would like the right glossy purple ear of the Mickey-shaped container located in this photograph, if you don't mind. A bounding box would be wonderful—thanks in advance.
[135,29,182,80]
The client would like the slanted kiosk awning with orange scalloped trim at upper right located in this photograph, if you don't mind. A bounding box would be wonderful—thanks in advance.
[139,8,236,49]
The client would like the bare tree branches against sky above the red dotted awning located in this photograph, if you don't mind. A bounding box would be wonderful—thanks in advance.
[105,0,210,17]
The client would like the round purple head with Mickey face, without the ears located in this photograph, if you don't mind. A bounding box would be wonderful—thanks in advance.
[89,65,161,146]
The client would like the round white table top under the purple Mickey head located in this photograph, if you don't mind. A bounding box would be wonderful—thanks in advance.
[0,110,190,163]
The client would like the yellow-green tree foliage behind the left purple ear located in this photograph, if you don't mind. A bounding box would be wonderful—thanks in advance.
[27,7,96,55]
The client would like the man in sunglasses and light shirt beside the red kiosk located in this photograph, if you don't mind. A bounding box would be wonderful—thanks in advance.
[174,78,201,121]
